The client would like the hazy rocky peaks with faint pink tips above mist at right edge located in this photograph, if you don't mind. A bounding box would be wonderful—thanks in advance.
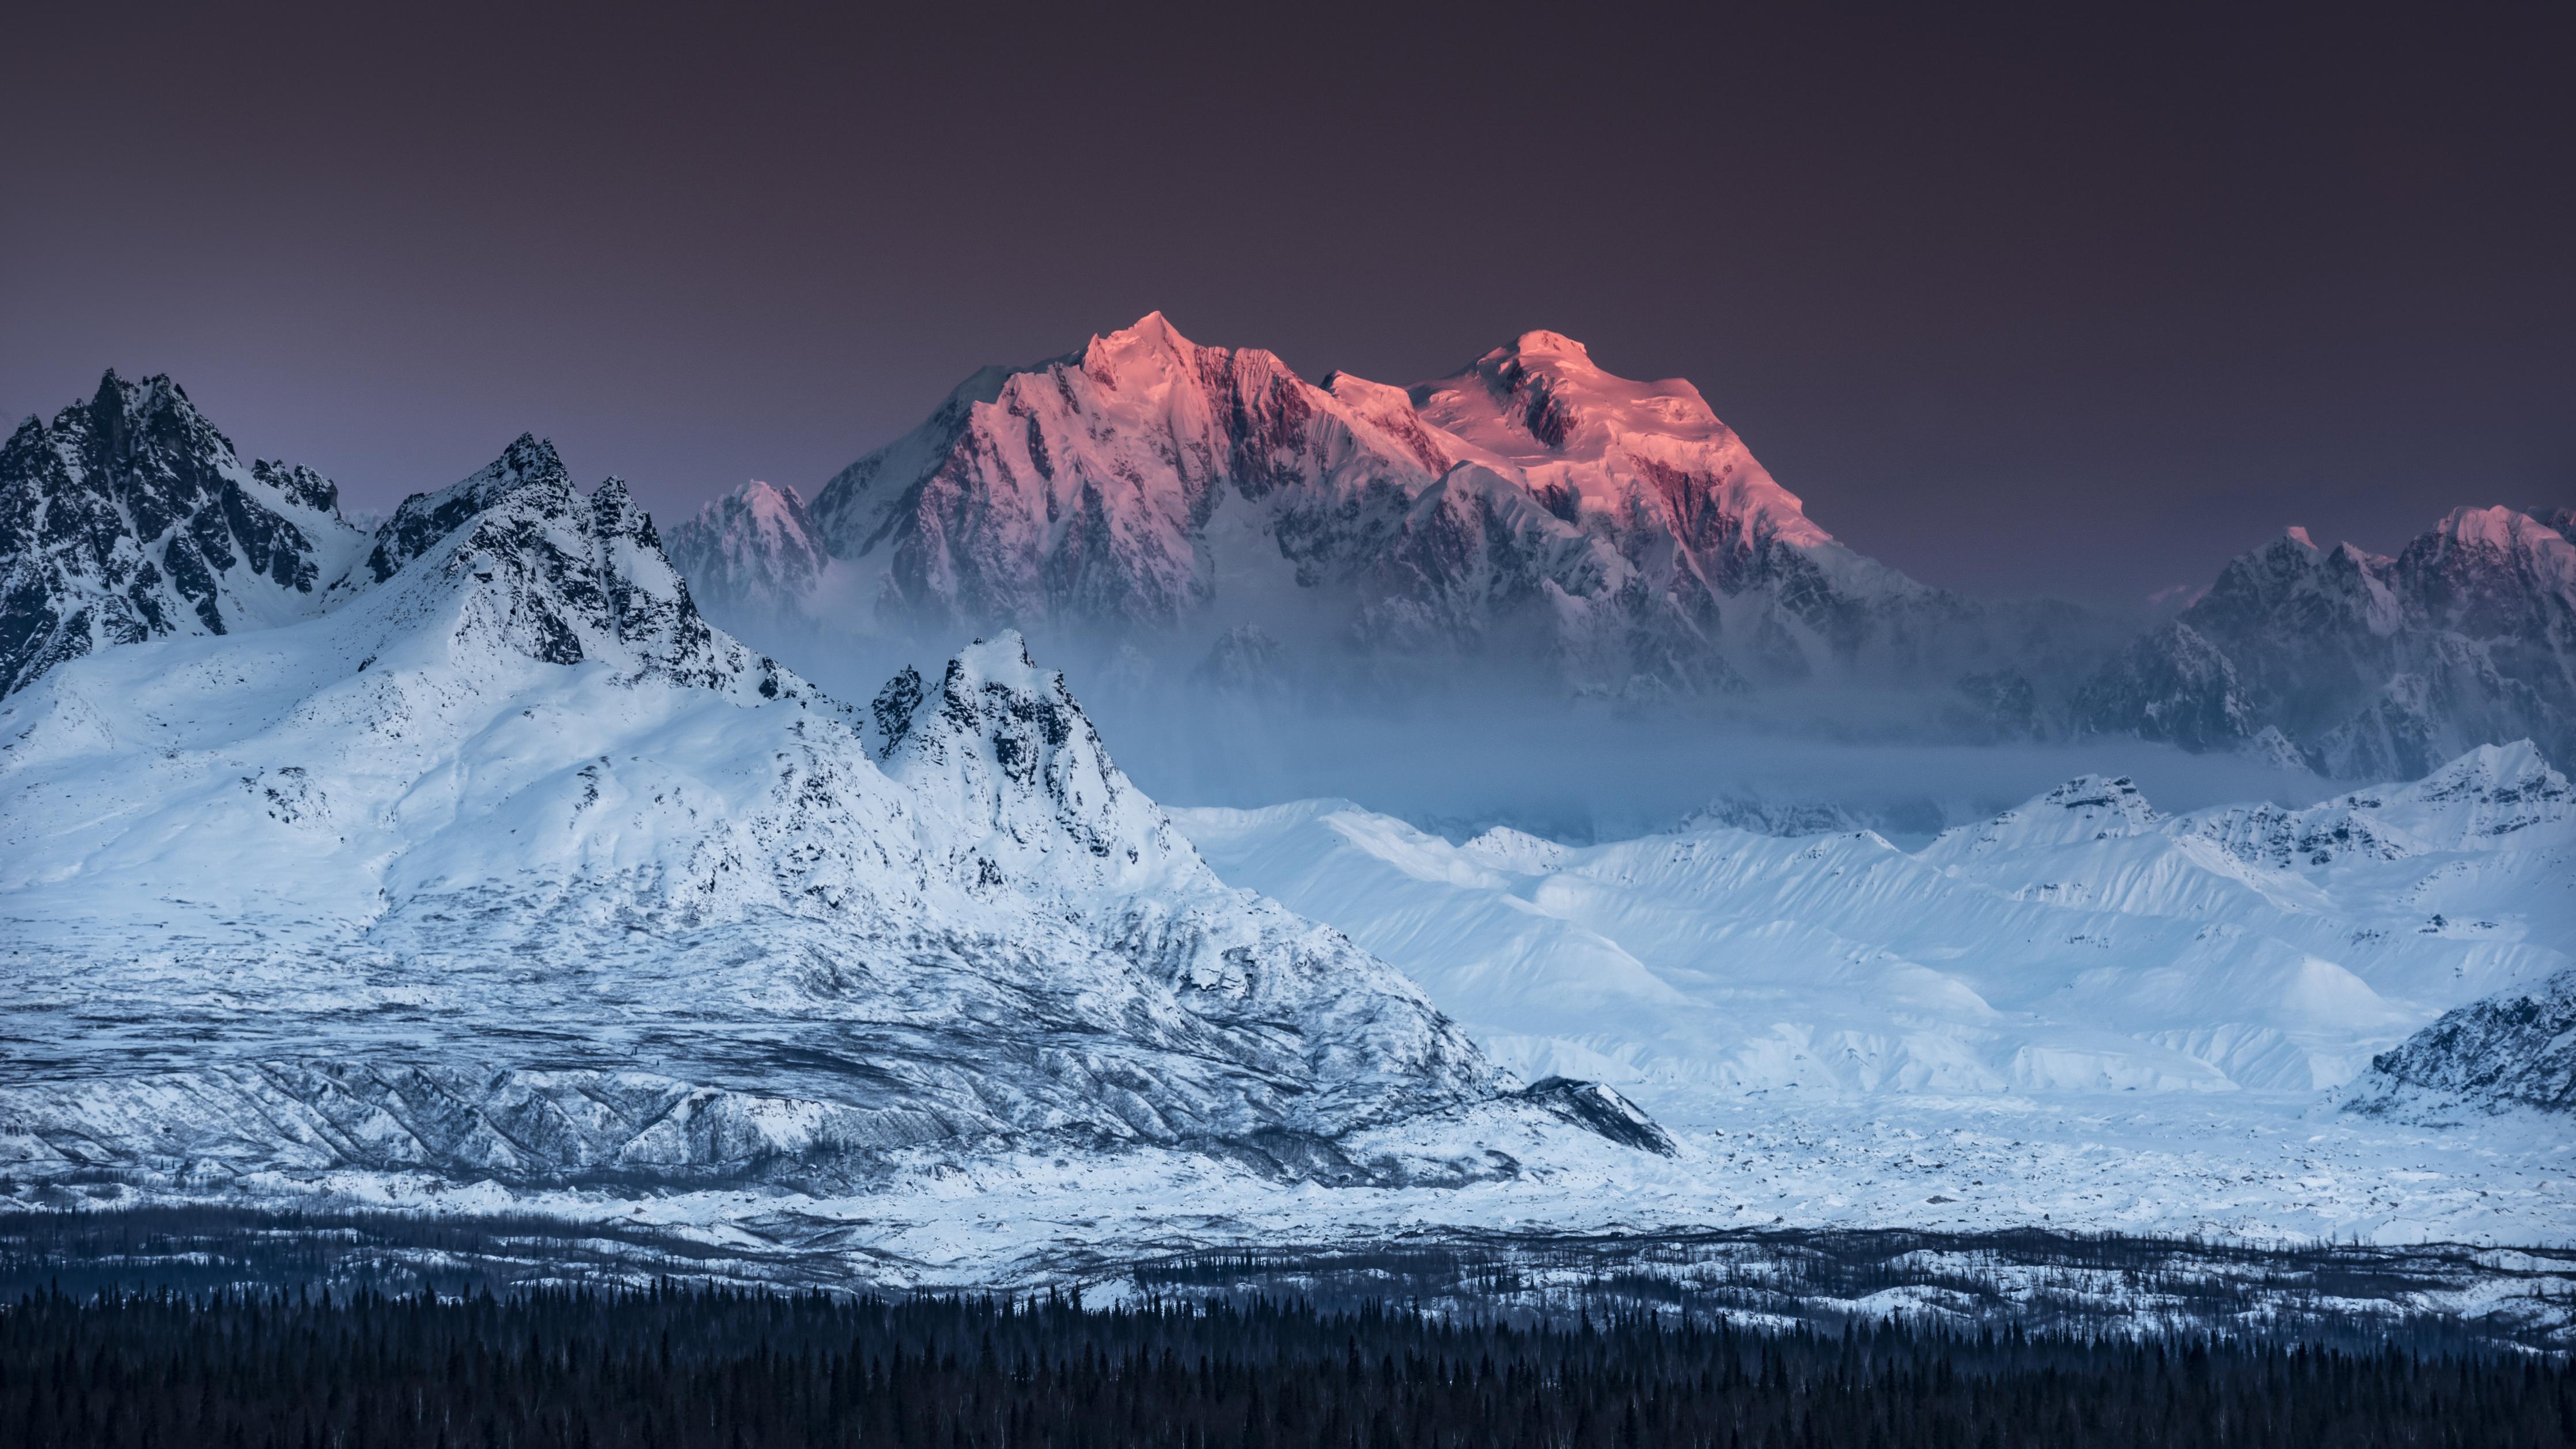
[2081,508,2576,778]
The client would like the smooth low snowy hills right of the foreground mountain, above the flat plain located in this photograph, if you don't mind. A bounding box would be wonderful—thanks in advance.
[1177,745,2576,1117]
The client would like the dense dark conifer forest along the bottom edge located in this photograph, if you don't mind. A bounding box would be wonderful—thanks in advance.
[0,1287,2576,1449]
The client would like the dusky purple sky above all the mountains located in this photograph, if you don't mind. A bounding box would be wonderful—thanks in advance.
[0,0,2576,603]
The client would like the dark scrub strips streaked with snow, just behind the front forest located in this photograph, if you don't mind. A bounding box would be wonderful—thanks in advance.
[15,1204,2576,1353]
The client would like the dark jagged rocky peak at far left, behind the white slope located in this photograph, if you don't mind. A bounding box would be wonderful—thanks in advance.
[0,371,366,696]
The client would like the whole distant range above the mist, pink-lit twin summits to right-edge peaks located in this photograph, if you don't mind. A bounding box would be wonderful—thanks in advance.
[649,315,2576,778]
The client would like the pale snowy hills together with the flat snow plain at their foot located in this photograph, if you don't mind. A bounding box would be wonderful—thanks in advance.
[1154,745,2576,1243]
